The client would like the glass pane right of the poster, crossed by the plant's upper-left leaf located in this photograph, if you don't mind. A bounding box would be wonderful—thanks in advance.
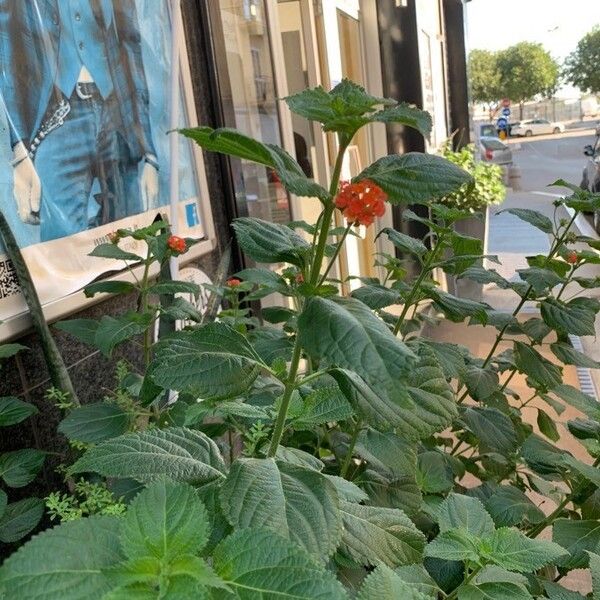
[219,0,290,223]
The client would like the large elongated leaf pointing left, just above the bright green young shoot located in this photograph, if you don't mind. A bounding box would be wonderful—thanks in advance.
[69,427,225,484]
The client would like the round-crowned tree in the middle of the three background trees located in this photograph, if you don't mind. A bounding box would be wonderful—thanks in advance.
[498,42,559,119]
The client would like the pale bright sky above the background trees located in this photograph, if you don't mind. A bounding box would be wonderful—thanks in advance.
[466,0,600,95]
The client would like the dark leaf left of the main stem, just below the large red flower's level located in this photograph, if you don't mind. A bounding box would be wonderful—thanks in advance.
[233,217,310,267]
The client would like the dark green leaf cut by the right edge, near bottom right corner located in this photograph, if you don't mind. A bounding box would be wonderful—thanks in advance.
[552,519,600,570]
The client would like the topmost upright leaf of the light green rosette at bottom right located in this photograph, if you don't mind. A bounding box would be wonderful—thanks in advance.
[437,494,494,538]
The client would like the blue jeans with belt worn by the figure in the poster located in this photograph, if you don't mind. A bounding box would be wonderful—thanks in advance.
[34,87,142,242]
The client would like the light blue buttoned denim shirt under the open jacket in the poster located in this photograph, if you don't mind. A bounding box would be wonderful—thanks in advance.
[56,0,113,99]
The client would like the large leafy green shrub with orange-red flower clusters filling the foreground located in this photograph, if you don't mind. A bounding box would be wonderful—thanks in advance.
[0,81,600,600]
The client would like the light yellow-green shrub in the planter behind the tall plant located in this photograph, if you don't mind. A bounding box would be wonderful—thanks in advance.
[442,142,506,212]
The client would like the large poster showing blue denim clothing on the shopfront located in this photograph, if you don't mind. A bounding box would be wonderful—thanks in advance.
[0,0,211,320]
